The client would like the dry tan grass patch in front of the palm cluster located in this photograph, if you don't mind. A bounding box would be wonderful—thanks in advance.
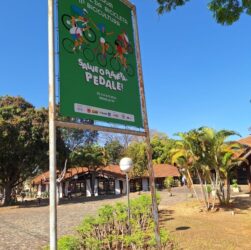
[160,198,251,250]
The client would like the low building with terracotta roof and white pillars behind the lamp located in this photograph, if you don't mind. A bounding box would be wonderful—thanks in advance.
[32,164,180,198]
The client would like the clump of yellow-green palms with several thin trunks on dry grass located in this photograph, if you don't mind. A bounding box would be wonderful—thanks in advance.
[172,127,244,209]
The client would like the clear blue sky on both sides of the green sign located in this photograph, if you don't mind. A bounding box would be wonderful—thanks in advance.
[0,0,251,136]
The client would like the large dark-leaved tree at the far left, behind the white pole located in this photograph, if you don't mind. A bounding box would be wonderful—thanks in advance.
[0,96,67,205]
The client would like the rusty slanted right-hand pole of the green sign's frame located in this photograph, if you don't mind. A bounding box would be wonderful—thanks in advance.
[132,6,161,249]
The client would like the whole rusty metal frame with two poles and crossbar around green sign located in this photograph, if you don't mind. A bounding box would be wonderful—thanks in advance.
[48,0,161,250]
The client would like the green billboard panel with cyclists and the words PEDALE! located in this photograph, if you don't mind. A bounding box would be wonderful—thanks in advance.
[58,0,143,127]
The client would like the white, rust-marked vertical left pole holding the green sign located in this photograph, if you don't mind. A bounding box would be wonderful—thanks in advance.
[48,0,57,250]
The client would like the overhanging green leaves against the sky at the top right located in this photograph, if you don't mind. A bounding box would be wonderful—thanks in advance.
[157,0,251,25]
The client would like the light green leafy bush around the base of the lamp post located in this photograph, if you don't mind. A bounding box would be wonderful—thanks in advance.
[56,195,169,250]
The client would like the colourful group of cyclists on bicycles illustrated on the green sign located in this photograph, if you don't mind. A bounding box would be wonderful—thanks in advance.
[61,5,135,77]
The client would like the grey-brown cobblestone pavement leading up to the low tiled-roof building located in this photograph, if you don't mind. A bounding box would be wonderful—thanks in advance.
[0,187,229,250]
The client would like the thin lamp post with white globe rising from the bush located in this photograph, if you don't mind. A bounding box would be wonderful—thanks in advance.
[119,157,133,234]
